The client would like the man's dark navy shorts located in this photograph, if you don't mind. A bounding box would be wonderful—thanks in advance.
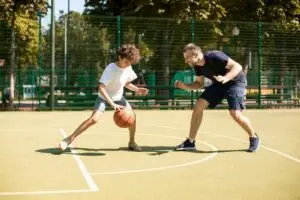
[200,84,245,110]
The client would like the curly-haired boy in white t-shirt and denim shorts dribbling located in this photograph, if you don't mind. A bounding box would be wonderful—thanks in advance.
[59,44,148,151]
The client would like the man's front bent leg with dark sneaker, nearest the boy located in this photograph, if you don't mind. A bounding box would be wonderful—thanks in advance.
[175,98,209,150]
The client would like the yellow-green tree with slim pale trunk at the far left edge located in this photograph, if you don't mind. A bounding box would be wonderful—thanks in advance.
[0,0,48,106]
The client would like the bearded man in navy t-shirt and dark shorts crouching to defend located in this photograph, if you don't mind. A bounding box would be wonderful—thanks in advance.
[175,43,260,152]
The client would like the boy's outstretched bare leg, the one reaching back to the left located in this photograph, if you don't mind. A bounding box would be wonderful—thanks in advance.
[59,110,103,151]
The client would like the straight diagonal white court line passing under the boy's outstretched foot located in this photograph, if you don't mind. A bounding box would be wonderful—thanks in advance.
[60,128,99,191]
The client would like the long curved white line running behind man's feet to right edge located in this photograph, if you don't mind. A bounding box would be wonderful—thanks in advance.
[149,125,300,164]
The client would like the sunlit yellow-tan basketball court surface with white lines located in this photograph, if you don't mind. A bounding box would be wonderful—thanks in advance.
[0,110,300,200]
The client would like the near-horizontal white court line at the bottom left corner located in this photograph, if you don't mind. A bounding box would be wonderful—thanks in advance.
[0,190,94,196]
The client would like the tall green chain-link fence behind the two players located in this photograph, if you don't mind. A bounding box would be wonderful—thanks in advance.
[0,12,300,109]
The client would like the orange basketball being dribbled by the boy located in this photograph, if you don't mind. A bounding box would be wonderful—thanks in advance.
[114,108,135,128]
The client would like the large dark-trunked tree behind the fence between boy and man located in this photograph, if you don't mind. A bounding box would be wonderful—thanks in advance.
[85,0,225,103]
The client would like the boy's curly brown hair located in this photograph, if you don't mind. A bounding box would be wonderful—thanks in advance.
[117,44,141,64]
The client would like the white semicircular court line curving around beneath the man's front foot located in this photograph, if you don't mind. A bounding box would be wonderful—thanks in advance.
[90,133,218,176]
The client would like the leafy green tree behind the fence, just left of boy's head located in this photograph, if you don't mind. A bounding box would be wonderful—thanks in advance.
[44,12,112,88]
